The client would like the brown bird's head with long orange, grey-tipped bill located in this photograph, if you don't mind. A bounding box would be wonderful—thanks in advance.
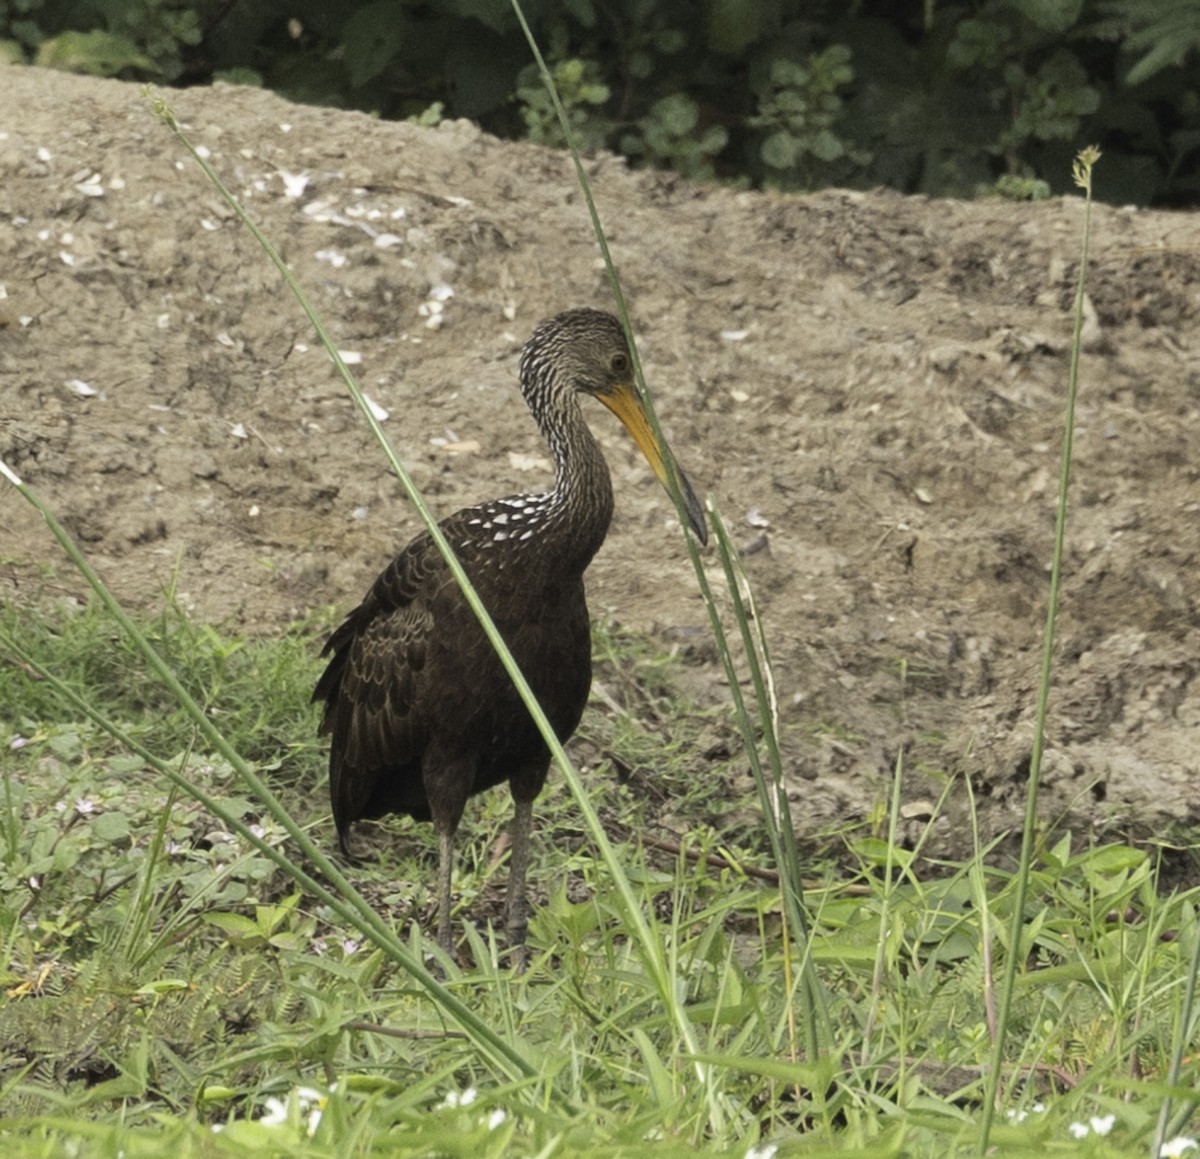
[521,308,708,544]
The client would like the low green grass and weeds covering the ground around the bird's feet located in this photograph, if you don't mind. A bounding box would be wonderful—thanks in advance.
[0,609,1198,1155]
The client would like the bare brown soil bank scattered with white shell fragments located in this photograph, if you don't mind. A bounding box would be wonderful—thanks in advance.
[0,66,1200,853]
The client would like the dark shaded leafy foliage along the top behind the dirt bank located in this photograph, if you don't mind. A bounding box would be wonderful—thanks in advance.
[0,0,1200,204]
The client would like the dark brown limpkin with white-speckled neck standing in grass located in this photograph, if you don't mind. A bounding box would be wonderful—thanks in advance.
[313,310,707,953]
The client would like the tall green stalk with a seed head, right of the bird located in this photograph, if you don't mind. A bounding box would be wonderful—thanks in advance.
[979,146,1100,1154]
